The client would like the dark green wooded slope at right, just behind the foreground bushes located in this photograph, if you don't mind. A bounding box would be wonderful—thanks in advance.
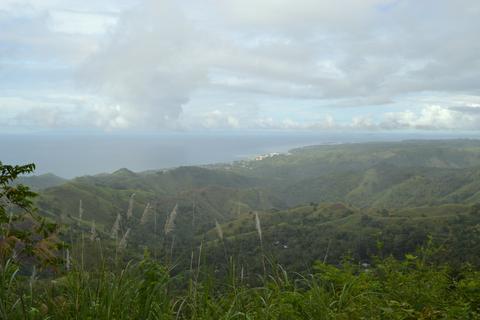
[202,203,480,271]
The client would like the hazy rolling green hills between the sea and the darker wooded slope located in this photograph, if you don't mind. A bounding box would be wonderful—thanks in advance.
[39,140,480,220]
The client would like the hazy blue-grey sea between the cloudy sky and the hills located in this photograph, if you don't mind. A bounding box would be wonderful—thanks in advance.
[0,131,479,178]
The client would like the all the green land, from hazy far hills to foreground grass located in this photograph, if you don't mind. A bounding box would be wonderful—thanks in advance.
[0,140,480,319]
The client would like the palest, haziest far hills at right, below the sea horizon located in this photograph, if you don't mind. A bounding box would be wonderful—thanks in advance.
[223,140,480,208]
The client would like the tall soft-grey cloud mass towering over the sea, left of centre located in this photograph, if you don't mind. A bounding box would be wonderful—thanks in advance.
[81,0,211,128]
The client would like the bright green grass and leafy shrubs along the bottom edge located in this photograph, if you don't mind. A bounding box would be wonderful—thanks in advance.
[0,250,480,319]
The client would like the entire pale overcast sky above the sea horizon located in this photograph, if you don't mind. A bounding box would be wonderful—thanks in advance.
[0,0,480,133]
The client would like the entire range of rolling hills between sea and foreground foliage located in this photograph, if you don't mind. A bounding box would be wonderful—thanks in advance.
[30,140,480,269]
